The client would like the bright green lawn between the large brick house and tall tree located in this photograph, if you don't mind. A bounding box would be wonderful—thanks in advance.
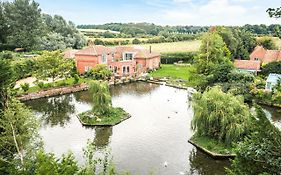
[150,64,192,80]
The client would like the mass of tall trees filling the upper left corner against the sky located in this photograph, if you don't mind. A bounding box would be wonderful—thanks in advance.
[0,0,86,50]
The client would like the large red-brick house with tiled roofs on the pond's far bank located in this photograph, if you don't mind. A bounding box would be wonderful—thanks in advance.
[75,45,160,76]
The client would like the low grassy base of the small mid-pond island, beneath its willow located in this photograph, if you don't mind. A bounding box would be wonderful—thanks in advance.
[78,108,129,126]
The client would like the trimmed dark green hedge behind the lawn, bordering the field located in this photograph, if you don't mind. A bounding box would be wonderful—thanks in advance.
[161,52,197,64]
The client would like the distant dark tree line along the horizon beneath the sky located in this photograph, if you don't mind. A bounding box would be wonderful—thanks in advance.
[77,23,281,38]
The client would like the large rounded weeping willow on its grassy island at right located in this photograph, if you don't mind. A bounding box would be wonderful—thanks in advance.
[189,86,251,158]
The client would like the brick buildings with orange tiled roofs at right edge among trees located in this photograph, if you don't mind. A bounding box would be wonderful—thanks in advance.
[234,46,281,73]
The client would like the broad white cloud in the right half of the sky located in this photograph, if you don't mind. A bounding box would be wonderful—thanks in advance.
[162,0,281,26]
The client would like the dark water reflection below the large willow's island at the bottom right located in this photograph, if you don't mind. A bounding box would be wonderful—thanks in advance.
[189,148,230,175]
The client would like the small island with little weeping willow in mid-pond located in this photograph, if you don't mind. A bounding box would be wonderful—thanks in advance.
[77,81,131,126]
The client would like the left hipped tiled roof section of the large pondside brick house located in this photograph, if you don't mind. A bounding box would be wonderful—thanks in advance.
[75,45,112,56]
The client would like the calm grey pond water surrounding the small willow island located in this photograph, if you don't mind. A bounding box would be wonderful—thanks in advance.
[26,83,229,175]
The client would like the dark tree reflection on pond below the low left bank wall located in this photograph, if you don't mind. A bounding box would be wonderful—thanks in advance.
[26,95,75,127]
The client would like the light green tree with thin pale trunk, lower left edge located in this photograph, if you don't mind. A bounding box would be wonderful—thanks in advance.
[0,99,39,172]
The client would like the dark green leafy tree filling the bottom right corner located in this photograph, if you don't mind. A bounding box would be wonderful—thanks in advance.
[228,106,281,175]
